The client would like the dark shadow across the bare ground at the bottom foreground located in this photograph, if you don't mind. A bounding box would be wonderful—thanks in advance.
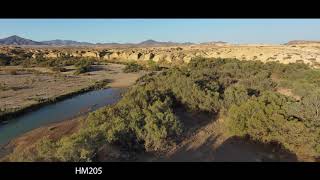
[166,136,298,162]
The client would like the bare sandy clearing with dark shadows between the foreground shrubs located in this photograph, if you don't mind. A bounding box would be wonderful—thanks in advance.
[134,111,304,162]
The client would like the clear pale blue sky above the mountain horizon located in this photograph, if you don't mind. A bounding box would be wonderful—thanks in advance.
[0,19,320,44]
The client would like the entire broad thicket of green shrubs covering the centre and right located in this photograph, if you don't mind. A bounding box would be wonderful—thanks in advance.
[10,58,320,161]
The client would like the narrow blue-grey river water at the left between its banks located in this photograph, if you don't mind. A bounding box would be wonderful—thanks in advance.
[0,88,124,145]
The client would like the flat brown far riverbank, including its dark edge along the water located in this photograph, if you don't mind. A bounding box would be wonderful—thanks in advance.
[0,64,145,122]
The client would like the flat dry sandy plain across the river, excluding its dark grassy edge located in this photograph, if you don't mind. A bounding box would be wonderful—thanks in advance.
[0,64,145,115]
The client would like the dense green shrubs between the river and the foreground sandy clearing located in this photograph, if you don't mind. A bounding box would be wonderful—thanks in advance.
[11,87,182,162]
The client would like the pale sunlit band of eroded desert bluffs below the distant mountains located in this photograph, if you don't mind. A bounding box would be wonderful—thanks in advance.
[0,43,320,67]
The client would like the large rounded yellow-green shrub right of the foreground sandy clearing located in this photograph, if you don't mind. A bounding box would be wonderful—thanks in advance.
[227,92,320,156]
